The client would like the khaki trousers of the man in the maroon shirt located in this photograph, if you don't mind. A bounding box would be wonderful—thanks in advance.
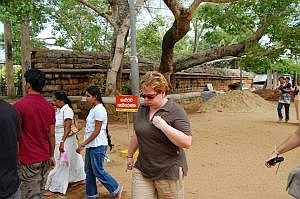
[18,160,50,199]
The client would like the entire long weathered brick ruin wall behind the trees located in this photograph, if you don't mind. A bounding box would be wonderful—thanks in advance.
[32,49,252,119]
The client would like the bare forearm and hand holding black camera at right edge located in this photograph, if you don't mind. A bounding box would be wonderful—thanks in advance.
[265,126,300,168]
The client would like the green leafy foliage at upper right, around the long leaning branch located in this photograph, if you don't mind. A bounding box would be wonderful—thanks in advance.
[190,0,300,73]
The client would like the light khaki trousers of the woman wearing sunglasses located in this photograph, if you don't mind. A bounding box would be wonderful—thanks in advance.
[131,168,184,199]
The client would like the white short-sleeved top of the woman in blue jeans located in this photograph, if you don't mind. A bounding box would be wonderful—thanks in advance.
[84,104,108,148]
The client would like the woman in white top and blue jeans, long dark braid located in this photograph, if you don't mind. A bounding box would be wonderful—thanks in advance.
[76,86,123,199]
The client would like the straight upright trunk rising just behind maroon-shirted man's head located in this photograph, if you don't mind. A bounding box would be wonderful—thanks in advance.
[21,15,31,95]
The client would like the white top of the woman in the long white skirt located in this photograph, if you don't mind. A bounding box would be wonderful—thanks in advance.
[55,104,74,144]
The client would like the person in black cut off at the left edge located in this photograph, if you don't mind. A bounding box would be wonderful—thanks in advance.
[0,100,21,199]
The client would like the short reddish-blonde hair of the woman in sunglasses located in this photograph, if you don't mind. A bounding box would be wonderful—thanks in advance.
[141,71,170,94]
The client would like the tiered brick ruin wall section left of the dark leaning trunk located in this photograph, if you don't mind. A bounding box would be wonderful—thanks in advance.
[32,49,158,96]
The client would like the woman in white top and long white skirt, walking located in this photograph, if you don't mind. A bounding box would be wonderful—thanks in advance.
[44,91,85,196]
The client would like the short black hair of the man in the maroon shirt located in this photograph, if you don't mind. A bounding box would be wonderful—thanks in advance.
[24,68,45,92]
